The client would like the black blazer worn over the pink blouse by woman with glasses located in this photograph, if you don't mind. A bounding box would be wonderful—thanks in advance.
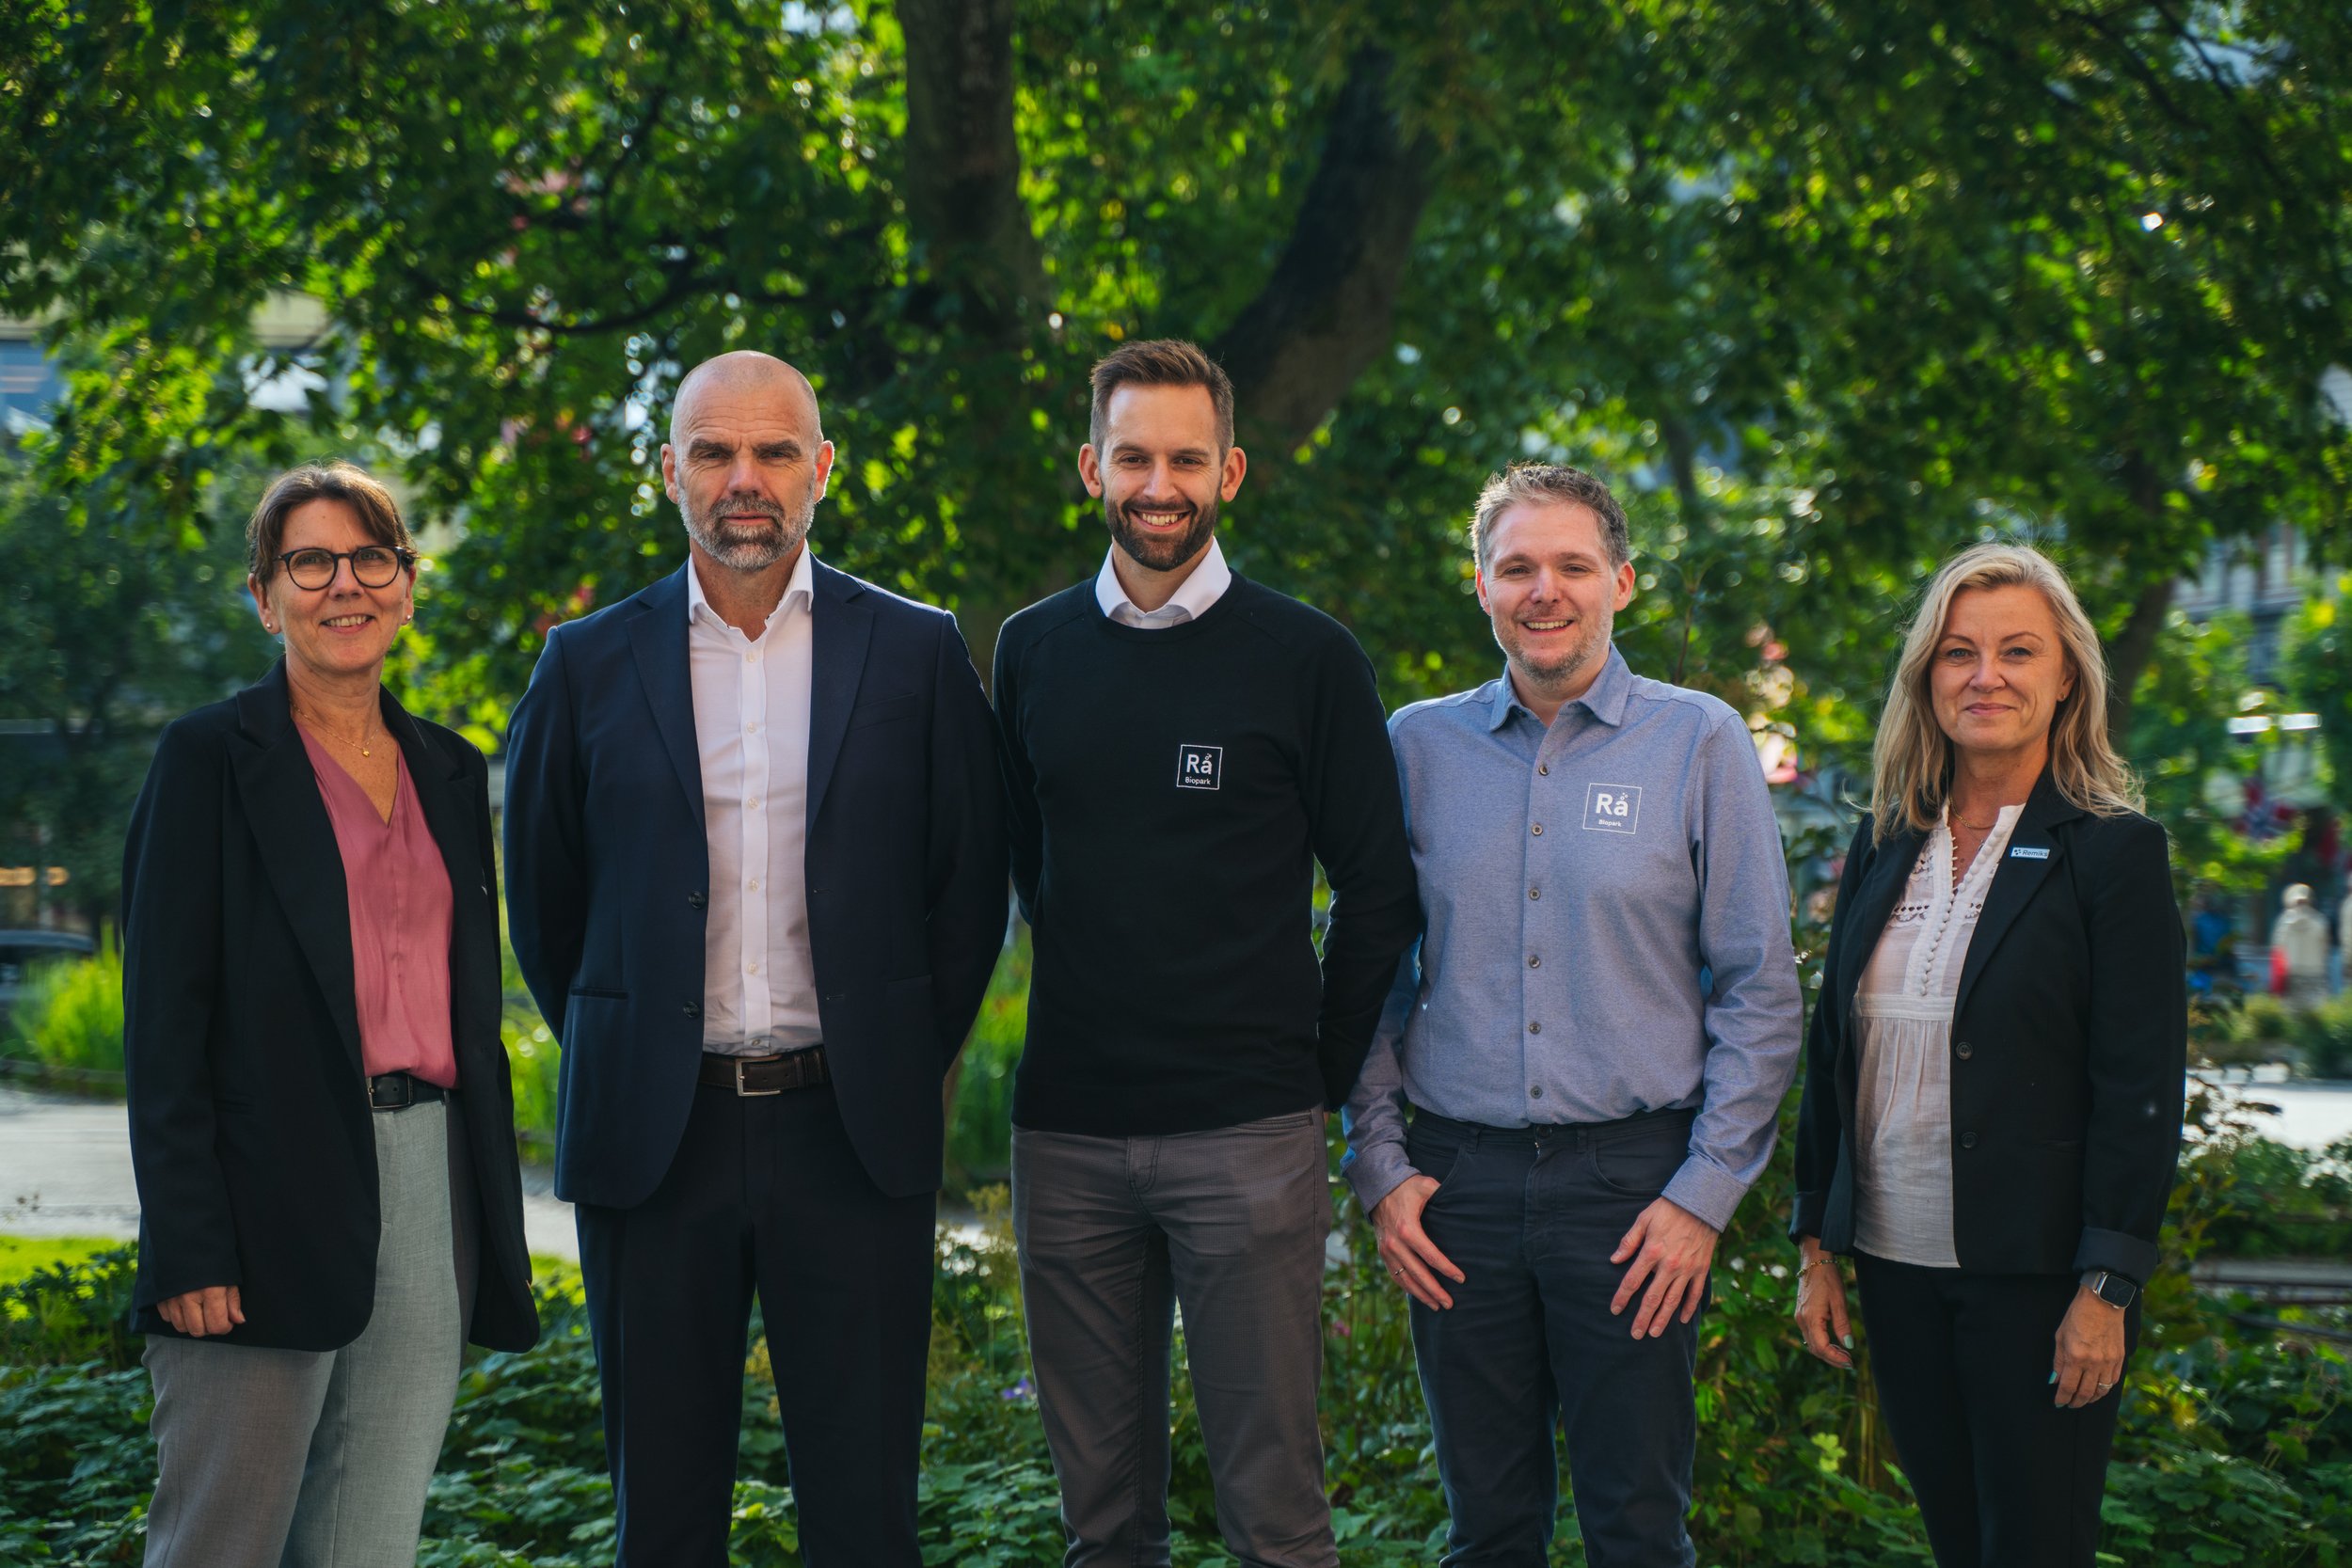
[122,663,539,1350]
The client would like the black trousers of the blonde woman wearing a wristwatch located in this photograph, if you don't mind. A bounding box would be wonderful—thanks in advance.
[1853,1253,2140,1568]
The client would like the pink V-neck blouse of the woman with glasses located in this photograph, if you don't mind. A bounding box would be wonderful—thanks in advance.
[296,726,456,1088]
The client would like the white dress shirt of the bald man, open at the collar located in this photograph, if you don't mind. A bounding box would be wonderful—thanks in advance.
[687,547,823,1055]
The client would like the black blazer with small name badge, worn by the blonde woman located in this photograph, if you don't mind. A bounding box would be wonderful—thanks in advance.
[1790,773,2187,1281]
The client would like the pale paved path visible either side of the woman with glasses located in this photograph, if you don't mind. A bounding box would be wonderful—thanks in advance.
[0,1086,579,1260]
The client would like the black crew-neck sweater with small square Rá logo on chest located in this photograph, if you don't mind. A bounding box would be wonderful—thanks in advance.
[993,576,1421,1138]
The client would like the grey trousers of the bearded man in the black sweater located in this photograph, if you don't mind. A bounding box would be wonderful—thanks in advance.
[1014,1112,1339,1568]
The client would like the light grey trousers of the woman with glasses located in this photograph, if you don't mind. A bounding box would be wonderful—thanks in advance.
[146,1101,475,1568]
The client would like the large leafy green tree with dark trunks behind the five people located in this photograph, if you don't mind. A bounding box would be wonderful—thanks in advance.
[0,0,2352,752]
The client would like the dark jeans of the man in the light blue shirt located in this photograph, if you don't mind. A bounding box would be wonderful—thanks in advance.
[1405,1112,1698,1568]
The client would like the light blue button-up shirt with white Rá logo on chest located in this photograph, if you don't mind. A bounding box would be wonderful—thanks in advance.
[1345,649,1804,1229]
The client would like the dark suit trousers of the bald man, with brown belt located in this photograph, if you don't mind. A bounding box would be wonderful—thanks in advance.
[577,1086,939,1568]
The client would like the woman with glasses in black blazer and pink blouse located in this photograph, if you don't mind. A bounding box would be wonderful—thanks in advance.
[122,463,539,1568]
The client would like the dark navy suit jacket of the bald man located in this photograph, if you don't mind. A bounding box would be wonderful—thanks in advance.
[506,562,1007,1209]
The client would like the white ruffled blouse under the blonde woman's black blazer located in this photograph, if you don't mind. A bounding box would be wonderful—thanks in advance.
[1853,806,2023,1270]
